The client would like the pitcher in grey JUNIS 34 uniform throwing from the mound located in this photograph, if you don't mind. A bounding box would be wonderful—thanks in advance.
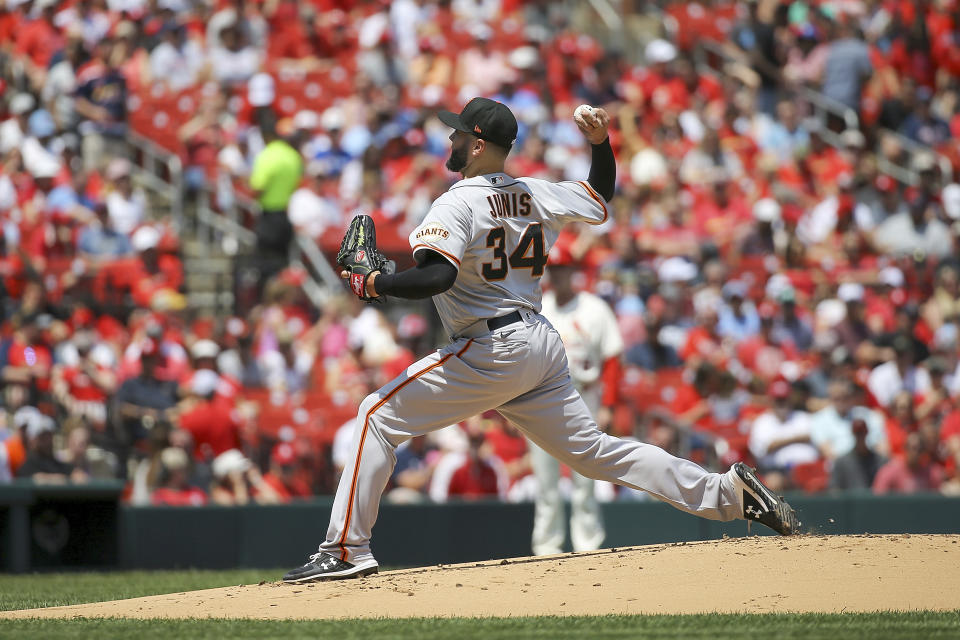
[283,98,799,583]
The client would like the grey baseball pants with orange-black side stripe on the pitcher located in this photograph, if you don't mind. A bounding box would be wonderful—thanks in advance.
[320,311,742,564]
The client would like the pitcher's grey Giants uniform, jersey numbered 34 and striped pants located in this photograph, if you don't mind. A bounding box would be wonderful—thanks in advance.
[320,173,742,569]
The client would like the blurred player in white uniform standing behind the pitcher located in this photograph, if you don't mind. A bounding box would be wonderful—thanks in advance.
[530,238,623,556]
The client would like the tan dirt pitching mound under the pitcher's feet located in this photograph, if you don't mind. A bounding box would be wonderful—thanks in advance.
[0,534,960,619]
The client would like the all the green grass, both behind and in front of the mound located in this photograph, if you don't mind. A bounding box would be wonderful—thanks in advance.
[0,569,960,640]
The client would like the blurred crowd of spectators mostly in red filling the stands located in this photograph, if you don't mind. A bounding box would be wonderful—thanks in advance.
[0,0,960,505]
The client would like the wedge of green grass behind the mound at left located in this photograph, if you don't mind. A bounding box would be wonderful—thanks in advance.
[0,567,289,612]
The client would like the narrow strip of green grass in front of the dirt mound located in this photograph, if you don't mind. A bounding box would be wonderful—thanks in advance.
[0,612,960,640]
